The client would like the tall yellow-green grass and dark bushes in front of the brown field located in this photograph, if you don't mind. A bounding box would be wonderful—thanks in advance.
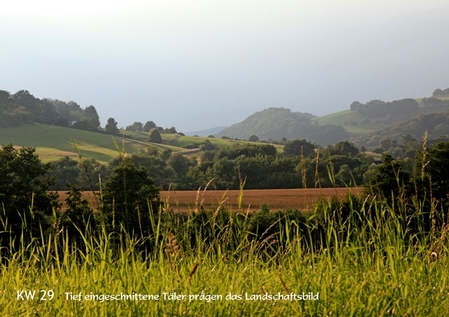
[0,138,449,316]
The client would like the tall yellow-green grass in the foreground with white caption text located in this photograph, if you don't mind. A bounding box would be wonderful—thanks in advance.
[0,189,449,316]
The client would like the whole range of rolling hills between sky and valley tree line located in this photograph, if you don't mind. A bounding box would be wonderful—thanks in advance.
[0,89,449,157]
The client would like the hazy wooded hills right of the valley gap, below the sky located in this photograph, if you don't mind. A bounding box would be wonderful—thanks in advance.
[217,89,449,147]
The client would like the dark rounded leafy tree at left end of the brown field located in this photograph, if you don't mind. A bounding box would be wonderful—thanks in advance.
[101,160,159,236]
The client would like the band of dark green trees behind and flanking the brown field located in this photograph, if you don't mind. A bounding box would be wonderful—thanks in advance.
[0,139,449,252]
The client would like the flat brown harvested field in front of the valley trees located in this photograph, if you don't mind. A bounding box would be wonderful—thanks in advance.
[59,187,363,212]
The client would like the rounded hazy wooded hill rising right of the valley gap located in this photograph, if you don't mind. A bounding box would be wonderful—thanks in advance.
[217,108,349,145]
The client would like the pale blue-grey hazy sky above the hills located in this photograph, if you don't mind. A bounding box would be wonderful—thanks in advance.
[0,0,449,132]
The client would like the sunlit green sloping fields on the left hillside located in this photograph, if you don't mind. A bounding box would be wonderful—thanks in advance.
[0,124,283,163]
